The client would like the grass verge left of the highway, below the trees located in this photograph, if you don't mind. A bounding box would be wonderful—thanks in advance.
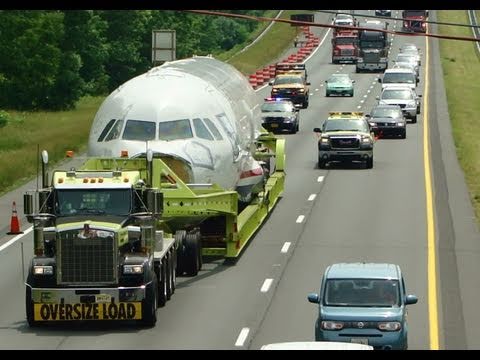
[0,10,311,195]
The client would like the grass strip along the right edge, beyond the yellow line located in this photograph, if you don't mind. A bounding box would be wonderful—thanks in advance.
[438,10,480,221]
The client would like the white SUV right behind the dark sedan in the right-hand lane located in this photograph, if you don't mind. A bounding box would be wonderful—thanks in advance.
[377,86,422,123]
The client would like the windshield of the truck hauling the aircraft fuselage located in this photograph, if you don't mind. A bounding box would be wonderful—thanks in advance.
[56,189,132,216]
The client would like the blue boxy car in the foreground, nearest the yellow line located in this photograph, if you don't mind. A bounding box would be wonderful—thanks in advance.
[308,263,418,350]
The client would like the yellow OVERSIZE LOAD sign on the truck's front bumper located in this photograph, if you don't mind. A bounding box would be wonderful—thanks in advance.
[34,302,142,321]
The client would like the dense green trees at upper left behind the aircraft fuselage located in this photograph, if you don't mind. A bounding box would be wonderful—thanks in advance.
[0,10,265,110]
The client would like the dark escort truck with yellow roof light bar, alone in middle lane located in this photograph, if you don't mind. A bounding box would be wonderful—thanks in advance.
[313,111,374,169]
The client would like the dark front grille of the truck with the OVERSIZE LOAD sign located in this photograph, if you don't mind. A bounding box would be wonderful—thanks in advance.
[57,229,117,285]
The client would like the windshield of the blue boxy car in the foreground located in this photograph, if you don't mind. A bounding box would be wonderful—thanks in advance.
[323,279,400,307]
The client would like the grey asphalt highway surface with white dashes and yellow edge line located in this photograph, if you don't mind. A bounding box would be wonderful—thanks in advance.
[0,10,480,349]
